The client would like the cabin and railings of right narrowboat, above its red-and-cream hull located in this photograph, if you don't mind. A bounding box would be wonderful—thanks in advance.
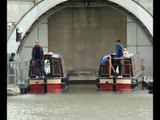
[98,55,142,77]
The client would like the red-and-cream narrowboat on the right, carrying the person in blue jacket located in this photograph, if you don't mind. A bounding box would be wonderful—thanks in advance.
[96,54,143,90]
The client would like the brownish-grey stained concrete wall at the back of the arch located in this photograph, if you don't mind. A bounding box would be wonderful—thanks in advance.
[48,7,126,71]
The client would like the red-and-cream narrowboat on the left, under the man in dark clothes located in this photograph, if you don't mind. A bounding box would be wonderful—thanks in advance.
[28,52,69,93]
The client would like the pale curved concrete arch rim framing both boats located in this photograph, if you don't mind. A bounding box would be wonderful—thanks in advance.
[7,0,153,53]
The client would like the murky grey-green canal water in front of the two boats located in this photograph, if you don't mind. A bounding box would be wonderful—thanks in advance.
[7,85,153,120]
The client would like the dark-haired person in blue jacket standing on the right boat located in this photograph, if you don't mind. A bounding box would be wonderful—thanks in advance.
[114,40,124,77]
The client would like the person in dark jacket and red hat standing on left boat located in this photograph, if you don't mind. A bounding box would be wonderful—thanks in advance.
[32,41,44,78]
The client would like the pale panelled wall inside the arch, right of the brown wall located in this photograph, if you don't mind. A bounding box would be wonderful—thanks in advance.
[127,16,153,76]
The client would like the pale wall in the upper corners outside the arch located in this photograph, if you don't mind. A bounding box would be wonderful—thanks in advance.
[7,0,153,23]
